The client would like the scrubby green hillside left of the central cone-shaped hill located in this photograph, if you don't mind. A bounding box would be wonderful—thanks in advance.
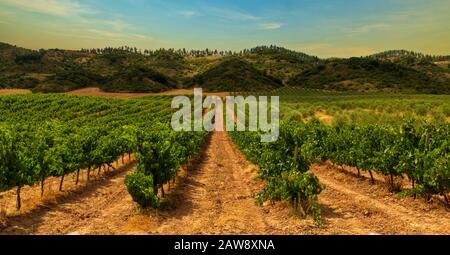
[0,44,184,92]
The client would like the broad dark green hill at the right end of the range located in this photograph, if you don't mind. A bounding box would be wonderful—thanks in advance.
[288,57,450,93]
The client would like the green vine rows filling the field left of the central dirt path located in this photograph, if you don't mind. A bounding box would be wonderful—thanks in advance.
[0,95,206,209]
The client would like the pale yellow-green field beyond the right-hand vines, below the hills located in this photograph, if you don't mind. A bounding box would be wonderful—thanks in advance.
[273,88,450,124]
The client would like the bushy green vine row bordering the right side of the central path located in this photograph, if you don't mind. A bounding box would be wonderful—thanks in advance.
[230,123,323,225]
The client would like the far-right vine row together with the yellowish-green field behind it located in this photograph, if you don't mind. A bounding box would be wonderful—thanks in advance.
[278,88,450,204]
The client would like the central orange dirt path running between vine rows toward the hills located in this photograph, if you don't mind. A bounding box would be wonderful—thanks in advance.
[131,132,267,234]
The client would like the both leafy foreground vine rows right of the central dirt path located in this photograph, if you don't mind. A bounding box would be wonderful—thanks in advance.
[231,120,450,214]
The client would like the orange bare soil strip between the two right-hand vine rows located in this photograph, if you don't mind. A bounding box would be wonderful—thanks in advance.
[311,162,450,234]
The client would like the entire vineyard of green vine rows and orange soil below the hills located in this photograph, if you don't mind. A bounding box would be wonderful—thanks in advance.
[0,90,450,234]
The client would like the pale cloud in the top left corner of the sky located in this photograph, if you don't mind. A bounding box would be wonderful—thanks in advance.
[0,0,96,17]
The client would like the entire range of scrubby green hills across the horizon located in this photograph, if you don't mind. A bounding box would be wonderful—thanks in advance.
[0,43,450,93]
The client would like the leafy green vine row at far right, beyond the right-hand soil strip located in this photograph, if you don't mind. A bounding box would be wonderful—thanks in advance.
[311,121,450,203]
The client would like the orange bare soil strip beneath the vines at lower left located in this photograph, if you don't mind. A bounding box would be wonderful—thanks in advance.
[0,157,135,234]
